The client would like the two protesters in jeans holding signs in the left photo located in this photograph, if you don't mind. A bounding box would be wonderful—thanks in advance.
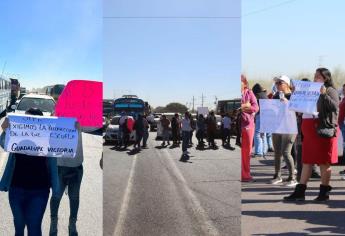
[0,108,83,236]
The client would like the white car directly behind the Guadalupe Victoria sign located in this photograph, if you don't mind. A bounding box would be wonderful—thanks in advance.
[11,93,55,116]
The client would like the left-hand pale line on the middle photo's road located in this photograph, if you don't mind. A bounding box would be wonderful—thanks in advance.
[114,155,137,236]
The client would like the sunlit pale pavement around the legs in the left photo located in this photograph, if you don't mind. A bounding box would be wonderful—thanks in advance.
[0,117,103,236]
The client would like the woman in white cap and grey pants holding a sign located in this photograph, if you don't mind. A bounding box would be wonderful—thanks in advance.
[270,75,297,186]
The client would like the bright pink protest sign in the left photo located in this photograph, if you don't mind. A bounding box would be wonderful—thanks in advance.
[55,80,103,127]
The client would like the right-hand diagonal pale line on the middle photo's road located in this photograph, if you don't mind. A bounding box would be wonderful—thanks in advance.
[158,149,220,236]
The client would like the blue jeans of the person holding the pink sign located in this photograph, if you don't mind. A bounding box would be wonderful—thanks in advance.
[50,165,83,221]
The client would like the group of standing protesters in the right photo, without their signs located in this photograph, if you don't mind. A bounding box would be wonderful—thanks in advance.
[241,68,345,201]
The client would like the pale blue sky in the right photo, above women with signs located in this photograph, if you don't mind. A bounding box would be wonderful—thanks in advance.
[242,0,345,79]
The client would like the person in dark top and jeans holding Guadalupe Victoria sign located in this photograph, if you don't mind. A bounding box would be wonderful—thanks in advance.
[0,108,58,236]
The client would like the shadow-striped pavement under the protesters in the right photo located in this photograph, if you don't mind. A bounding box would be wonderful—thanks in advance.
[242,152,345,235]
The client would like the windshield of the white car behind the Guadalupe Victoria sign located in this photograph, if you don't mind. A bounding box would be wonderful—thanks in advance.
[17,98,55,113]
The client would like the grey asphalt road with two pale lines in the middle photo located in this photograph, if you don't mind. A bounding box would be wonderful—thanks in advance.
[103,133,241,236]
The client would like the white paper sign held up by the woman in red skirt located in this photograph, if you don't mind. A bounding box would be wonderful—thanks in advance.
[289,80,322,114]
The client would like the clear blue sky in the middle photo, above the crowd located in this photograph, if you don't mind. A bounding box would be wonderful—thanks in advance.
[103,0,241,106]
